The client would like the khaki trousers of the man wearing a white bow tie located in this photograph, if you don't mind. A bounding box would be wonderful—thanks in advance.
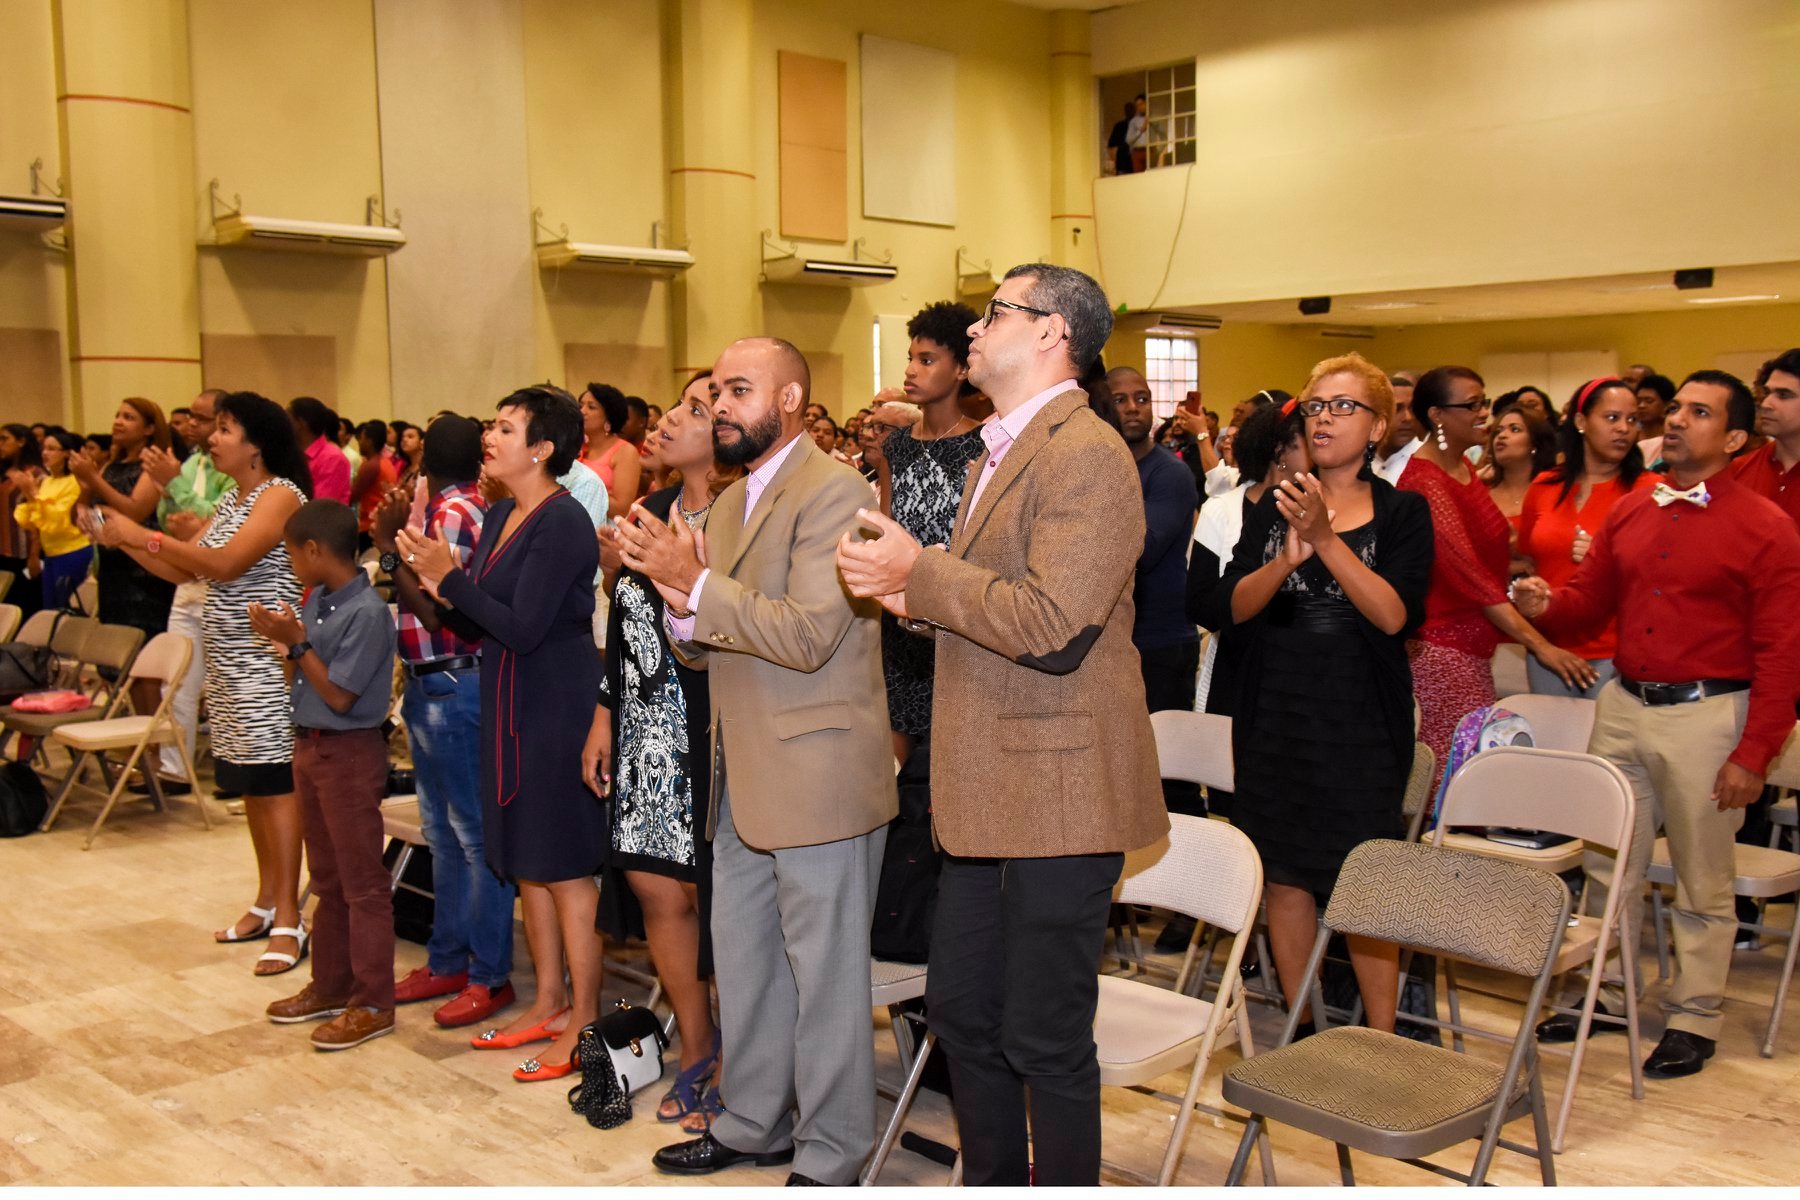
[1588,680,1750,1040]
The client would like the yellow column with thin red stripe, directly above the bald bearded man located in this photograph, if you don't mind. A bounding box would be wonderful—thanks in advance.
[662,0,763,380]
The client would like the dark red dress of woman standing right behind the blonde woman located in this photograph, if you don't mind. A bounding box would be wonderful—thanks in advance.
[1399,455,1512,783]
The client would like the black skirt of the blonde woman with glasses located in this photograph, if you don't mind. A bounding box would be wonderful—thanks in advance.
[1231,626,1411,903]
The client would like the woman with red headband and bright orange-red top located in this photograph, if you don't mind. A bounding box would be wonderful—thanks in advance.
[1519,378,1661,700]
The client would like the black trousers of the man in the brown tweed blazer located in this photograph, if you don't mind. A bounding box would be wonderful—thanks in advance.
[925,855,1125,1187]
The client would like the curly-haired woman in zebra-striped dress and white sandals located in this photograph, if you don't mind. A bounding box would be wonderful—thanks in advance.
[95,392,313,975]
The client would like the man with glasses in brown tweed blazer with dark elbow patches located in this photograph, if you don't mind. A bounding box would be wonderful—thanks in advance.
[839,263,1168,1186]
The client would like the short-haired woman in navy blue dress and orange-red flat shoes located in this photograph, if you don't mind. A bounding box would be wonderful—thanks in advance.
[400,387,608,1081]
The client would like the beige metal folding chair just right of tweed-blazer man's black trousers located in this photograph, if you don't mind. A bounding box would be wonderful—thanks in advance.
[1094,813,1273,1187]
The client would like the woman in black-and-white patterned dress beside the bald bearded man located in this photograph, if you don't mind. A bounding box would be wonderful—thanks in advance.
[581,372,736,1133]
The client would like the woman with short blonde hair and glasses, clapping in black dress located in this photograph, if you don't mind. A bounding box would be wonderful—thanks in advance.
[1197,354,1433,1036]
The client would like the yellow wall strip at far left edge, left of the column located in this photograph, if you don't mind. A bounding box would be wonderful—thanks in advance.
[0,0,68,421]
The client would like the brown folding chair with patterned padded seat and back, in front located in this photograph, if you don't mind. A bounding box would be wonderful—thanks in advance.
[1224,840,1570,1186]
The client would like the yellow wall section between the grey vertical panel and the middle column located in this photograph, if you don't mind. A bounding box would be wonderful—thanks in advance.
[524,0,675,407]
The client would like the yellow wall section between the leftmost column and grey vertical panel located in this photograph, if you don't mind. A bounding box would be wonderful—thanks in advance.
[187,0,388,417]
